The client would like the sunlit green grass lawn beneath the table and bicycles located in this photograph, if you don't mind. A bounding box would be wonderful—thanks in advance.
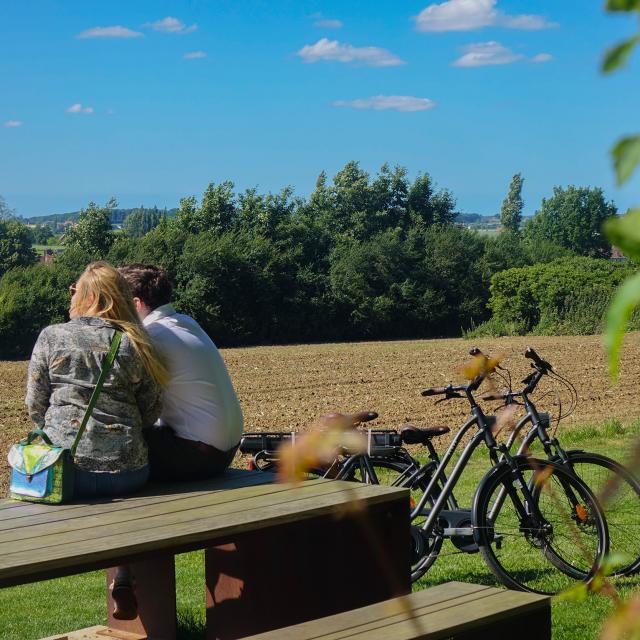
[0,422,640,640]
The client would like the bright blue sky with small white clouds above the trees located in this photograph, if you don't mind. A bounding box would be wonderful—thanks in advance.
[0,0,640,216]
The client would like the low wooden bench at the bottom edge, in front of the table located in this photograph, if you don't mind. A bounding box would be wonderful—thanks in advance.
[239,582,551,640]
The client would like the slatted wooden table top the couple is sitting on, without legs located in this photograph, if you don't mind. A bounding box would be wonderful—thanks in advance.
[0,469,407,587]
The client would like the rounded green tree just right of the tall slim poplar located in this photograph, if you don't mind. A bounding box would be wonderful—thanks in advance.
[524,186,617,258]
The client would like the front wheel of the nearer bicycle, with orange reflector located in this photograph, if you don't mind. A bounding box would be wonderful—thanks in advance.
[472,458,608,595]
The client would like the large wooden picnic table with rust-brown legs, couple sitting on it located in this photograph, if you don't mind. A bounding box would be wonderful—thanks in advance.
[0,470,410,640]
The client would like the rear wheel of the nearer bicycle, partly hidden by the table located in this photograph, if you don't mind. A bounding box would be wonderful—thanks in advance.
[344,454,443,582]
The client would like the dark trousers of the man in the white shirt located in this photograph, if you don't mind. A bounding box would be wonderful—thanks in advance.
[143,427,238,482]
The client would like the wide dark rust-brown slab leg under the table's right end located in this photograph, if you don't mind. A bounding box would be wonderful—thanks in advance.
[205,497,411,640]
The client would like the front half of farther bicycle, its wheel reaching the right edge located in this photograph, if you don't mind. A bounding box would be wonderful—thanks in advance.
[478,347,640,577]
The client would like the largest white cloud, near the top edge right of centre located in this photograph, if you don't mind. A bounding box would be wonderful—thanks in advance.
[415,0,558,31]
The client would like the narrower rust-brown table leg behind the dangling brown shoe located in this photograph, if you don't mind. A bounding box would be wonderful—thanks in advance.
[107,554,176,640]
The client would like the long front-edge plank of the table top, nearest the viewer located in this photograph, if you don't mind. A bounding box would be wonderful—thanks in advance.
[0,481,406,586]
